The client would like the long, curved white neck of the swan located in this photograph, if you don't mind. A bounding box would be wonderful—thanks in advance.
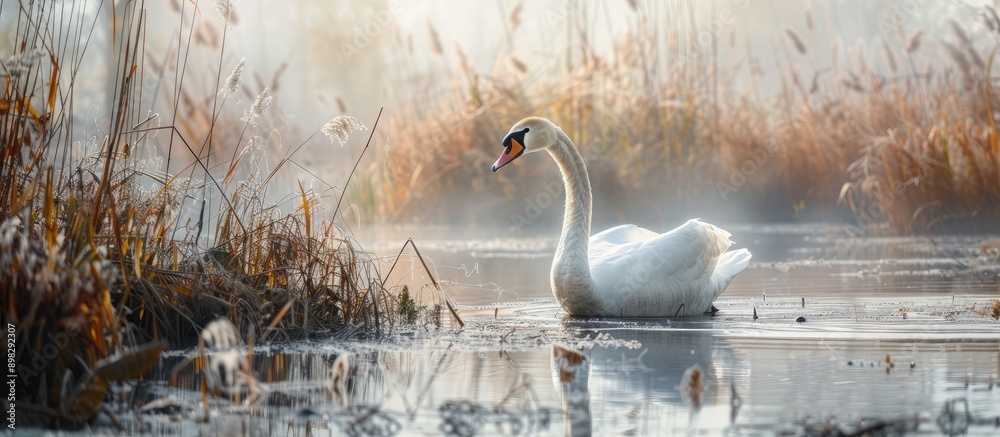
[547,130,599,315]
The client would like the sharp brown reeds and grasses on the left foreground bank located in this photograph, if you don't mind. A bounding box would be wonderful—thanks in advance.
[0,0,446,427]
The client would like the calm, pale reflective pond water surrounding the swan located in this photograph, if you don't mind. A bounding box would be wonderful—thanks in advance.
[118,226,1000,435]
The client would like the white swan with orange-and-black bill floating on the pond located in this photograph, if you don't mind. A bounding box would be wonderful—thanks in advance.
[493,117,751,317]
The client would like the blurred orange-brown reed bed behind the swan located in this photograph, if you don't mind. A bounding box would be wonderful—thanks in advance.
[369,2,1000,234]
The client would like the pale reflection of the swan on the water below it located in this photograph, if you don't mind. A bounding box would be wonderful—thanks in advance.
[551,320,739,436]
